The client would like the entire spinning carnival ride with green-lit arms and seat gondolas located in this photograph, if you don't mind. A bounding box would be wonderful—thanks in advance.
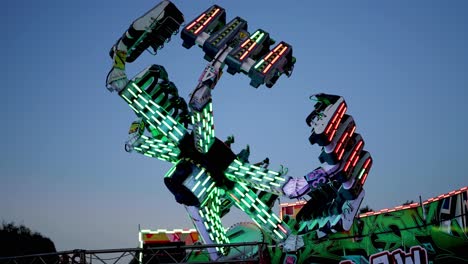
[106,1,372,260]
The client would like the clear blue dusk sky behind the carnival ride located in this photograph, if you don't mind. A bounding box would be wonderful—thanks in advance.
[0,0,468,250]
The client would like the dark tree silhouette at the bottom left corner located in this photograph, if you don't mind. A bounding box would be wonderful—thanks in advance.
[0,222,57,263]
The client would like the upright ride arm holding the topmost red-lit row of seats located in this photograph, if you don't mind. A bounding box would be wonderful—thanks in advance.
[181,5,295,153]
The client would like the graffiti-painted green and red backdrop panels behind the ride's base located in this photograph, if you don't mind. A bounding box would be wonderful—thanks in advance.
[140,187,468,264]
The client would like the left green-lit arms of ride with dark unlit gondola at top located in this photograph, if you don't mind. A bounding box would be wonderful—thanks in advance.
[106,1,189,157]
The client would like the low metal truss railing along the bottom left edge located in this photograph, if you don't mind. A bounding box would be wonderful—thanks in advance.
[0,242,267,264]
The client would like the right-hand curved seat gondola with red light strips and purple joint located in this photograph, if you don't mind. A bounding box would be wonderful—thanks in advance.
[283,94,372,236]
